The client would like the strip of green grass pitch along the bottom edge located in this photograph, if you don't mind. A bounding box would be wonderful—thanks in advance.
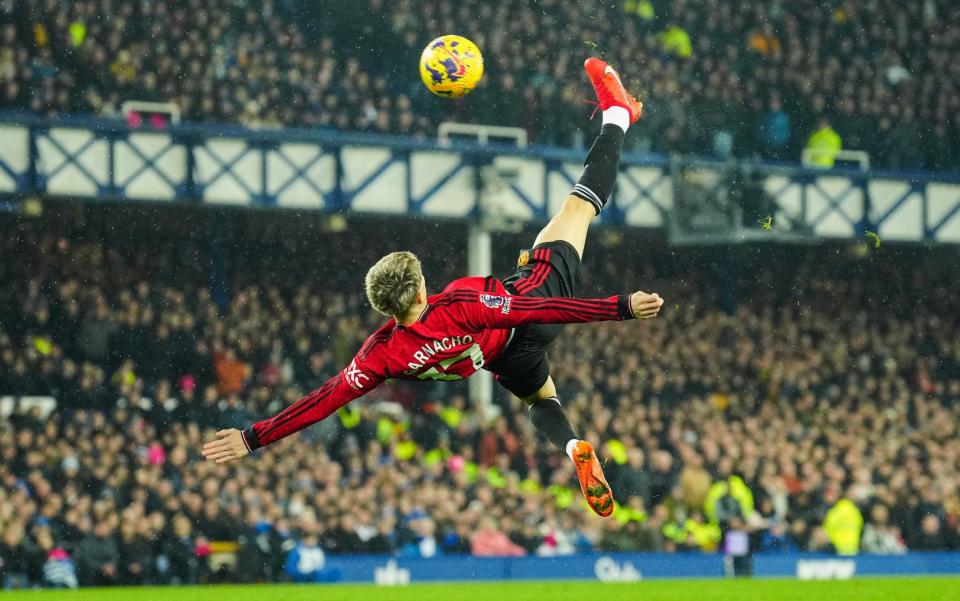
[0,577,960,601]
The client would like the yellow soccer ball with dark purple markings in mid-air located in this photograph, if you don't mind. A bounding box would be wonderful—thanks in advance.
[420,35,483,98]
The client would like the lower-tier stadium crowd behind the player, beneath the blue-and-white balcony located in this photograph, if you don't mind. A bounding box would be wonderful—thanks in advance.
[0,206,960,587]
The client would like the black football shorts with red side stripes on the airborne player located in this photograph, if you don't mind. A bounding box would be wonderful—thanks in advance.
[487,240,582,397]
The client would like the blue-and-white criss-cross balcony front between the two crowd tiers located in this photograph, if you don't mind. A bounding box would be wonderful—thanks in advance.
[0,114,960,242]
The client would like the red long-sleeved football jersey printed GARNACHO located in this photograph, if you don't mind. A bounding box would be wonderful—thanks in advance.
[243,277,633,451]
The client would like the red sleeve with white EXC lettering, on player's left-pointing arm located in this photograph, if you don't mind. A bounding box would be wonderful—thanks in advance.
[242,358,385,452]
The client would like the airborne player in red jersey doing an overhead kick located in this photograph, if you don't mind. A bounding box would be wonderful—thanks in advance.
[203,58,663,516]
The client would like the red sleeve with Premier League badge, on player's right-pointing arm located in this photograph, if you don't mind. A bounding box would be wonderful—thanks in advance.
[451,290,634,329]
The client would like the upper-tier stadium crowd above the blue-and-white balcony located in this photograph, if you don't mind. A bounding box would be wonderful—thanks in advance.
[0,0,960,170]
